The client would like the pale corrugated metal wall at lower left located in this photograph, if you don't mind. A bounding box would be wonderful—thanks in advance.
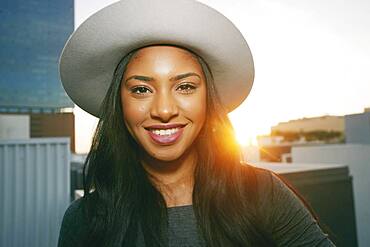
[0,138,70,247]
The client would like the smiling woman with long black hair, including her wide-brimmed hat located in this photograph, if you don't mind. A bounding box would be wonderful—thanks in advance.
[58,0,333,247]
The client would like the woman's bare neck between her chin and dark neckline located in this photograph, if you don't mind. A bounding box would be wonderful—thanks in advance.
[142,149,197,207]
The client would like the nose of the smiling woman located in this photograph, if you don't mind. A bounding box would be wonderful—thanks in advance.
[150,90,179,122]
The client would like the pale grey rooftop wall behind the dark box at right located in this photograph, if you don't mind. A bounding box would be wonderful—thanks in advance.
[292,144,370,247]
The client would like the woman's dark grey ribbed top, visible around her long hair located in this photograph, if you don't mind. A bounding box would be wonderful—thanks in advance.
[58,168,334,247]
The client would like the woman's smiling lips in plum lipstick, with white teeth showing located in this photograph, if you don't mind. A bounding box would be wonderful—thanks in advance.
[145,124,186,145]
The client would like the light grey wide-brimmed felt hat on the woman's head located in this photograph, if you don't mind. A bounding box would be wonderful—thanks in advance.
[59,0,254,117]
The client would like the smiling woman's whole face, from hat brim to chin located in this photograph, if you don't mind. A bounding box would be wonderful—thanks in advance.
[121,46,206,161]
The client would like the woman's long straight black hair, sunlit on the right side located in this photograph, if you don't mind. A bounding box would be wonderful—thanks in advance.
[83,44,272,247]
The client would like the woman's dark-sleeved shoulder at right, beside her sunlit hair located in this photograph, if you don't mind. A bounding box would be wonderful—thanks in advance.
[240,165,334,246]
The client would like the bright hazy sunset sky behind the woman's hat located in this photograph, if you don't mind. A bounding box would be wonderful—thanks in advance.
[75,0,370,153]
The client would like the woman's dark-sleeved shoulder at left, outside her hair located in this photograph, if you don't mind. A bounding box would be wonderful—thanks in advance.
[58,198,86,247]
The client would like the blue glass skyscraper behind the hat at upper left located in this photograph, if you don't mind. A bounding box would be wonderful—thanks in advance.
[0,0,74,112]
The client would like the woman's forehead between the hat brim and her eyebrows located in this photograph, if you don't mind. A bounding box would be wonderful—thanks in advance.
[126,45,202,74]
